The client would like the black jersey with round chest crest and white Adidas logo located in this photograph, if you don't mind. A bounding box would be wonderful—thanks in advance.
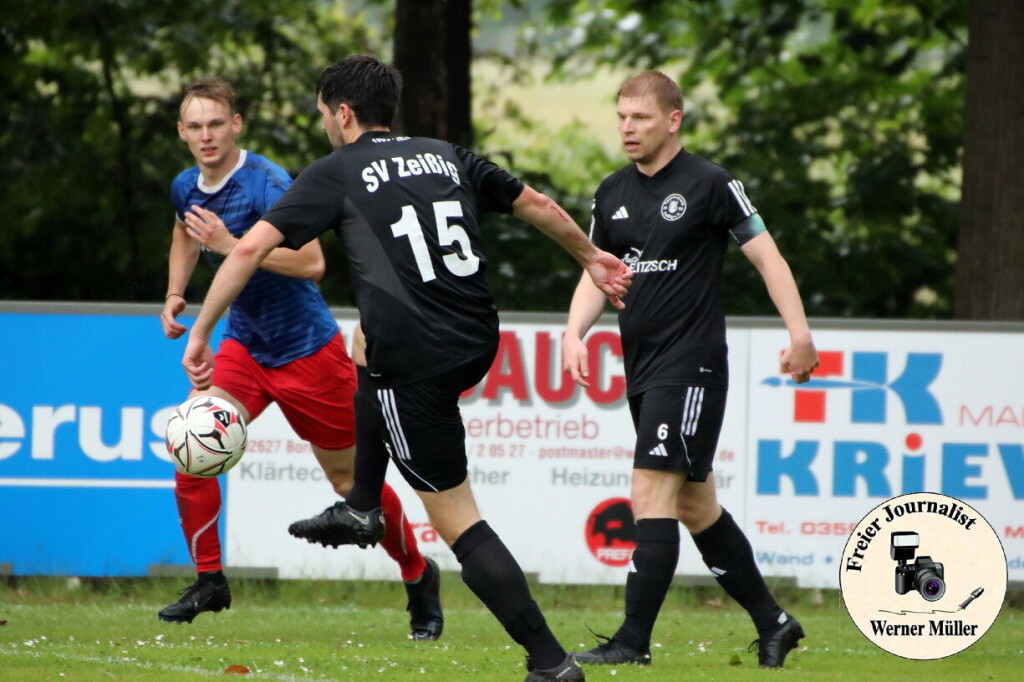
[591,150,756,395]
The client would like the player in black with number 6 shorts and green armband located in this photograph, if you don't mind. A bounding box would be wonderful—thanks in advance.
[563,72,818,668]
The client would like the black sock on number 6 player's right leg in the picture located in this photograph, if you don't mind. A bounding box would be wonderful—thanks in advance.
[693,509,782,635]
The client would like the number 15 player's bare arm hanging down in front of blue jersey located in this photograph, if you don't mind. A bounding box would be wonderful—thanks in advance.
[181,220,285,389]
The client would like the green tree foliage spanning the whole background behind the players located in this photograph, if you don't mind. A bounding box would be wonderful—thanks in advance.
[0,0,967,317]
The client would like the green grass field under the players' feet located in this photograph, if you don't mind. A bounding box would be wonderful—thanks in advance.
[0,573,1024,682]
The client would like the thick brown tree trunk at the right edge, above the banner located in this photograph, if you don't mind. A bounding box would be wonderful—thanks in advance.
[954,0,1024,319]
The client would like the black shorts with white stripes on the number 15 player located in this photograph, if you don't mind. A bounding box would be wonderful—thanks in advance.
[373,351,495,493]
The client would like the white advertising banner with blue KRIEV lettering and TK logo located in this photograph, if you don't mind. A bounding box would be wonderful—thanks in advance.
[744,323,1024,588]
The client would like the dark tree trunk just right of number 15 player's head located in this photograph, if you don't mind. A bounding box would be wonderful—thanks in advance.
[394,0,473,144]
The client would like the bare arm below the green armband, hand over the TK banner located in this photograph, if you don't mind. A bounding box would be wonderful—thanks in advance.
[740,232,818,384]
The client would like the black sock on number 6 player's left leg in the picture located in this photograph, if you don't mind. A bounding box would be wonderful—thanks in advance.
[614,518,679,651]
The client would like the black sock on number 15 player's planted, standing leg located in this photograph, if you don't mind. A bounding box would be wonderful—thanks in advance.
[452,520,565,669]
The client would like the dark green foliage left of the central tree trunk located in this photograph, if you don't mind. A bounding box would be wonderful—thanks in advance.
[0,0,380,302]
